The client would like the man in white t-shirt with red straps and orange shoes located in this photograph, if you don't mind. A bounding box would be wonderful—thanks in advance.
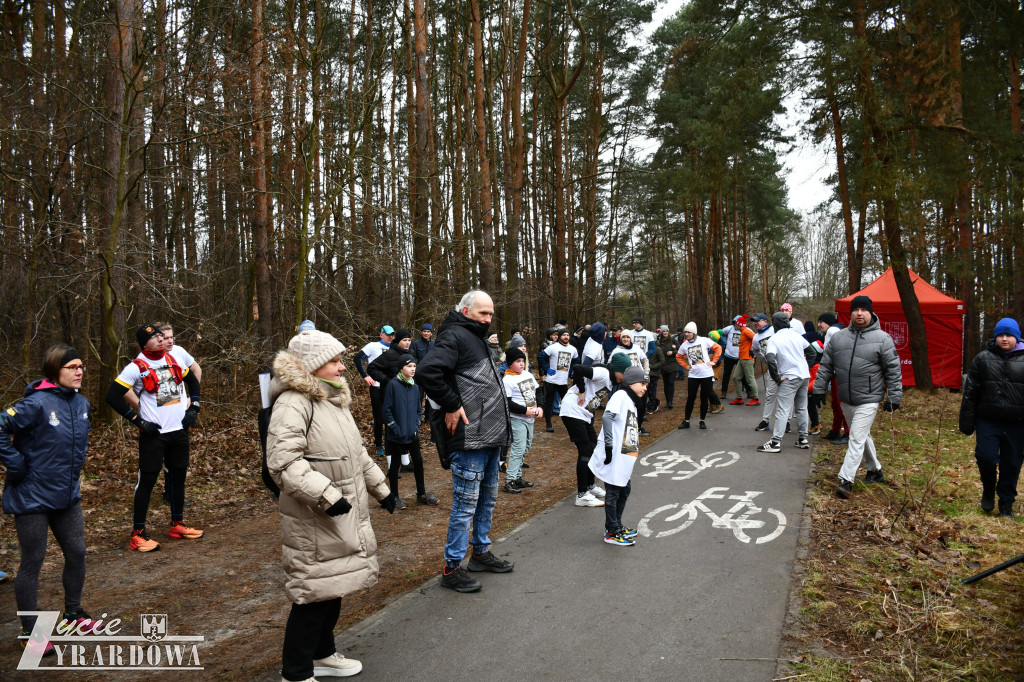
[106,325,203,552]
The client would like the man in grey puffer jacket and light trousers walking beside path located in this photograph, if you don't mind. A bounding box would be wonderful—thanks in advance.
[812,296,903,500]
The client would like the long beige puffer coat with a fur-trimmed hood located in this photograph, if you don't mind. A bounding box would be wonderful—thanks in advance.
[266,350,390,604]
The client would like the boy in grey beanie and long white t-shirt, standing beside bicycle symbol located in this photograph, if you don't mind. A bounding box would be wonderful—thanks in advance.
[590,367,649,547]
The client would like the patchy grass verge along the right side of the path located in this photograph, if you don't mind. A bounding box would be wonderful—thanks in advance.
[784,389,1024,682]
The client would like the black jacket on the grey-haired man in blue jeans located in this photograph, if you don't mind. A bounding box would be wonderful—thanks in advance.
[416,310,512,451]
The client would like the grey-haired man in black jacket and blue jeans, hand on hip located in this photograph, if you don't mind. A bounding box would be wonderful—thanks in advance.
[418,291,513,592]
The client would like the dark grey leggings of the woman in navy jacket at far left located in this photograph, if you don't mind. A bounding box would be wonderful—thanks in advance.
[14,501,85,631]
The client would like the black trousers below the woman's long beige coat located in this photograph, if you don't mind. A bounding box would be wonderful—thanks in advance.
[281,597,341,680]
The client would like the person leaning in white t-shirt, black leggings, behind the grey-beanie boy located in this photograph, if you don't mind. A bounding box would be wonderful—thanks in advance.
[558,365,615,507]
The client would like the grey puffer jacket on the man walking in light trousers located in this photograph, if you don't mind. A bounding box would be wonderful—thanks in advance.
[813,313,903,404]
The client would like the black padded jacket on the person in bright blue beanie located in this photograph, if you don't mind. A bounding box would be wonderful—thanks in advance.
[959,339,1024,435]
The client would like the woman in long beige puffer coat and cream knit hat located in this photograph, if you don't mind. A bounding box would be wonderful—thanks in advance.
[267,331,394,682]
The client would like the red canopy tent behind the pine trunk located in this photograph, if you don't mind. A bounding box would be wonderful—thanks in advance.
[836,267,964,388]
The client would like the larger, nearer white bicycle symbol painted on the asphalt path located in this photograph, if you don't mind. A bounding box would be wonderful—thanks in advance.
[637,487,785,545]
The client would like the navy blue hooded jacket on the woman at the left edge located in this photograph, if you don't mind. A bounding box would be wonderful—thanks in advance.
[0,379,92,514]
